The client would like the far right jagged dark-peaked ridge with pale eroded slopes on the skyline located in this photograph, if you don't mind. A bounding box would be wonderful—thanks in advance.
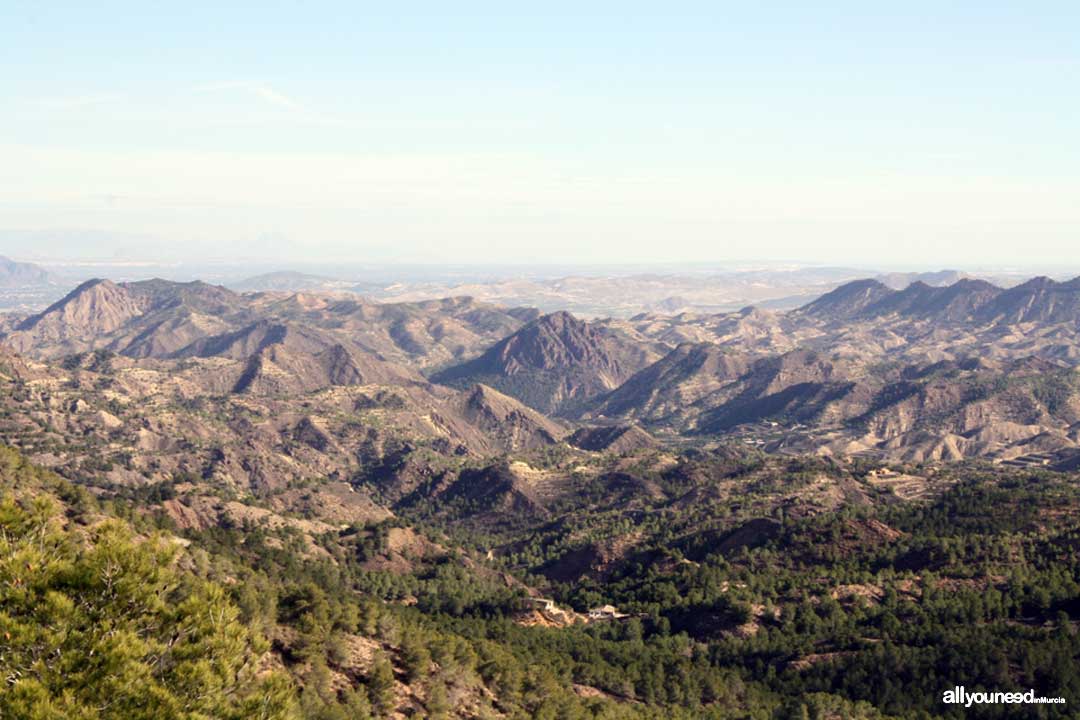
[604,279,1080,365]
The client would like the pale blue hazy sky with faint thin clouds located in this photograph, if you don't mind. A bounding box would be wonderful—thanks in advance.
[0,0,1080,267]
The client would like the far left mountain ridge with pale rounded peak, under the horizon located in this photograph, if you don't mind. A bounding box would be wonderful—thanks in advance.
[3,280,536,370]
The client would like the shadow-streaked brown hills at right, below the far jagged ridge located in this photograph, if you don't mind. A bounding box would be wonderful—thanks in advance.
[586,345,1080,461]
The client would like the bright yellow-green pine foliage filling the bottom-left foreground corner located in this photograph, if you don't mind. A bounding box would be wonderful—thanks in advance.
[0,450,297,720]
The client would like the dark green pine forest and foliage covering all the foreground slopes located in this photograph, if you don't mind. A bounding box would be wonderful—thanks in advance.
[0,442,1080,720]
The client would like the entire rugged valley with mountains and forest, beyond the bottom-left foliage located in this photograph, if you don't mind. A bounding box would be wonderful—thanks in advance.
[0,273,1080,718]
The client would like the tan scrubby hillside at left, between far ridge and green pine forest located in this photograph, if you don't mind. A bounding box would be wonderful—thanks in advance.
[0,345,566,498]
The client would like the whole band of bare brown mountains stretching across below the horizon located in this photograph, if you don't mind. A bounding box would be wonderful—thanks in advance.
[3,277,1080,474]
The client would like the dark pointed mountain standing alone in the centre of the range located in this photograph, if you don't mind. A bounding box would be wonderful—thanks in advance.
[431,312,657,415]
